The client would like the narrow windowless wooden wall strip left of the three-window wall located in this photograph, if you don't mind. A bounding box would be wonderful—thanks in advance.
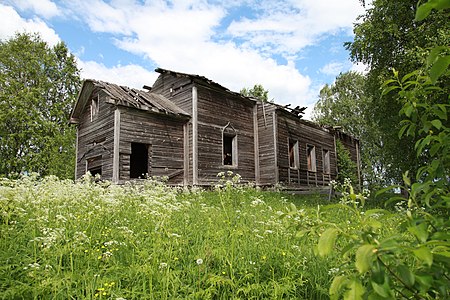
[258,103,276,185]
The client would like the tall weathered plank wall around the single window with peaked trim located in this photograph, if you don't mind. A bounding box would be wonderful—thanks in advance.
[197,85,255,185]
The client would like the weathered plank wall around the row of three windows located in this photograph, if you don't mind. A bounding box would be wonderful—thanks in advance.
[277,110,336,186]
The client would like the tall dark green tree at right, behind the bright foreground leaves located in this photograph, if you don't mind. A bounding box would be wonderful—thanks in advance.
[346,0,450,183]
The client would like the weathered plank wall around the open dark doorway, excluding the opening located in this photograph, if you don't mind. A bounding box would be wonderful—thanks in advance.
[119,108,186,184]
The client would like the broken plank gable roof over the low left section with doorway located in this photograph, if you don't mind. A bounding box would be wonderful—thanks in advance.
[70,79,189,123]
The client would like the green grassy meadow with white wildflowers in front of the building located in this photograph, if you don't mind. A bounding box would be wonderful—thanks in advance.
[0,175,398,300]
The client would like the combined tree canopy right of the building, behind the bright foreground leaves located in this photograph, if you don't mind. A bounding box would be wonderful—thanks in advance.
[316,0,450,183]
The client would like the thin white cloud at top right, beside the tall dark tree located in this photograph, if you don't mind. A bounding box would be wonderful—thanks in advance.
[228,0,364,55]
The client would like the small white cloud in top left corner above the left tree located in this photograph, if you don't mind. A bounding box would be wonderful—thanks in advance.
[0,4,60,45]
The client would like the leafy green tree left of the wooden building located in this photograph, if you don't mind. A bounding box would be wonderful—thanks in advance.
[0,34,80,178]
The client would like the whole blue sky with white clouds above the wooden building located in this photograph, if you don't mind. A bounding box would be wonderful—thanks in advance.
[0,0,367,118]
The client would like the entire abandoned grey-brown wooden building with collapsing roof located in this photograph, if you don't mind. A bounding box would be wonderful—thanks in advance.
[70,68,359,187]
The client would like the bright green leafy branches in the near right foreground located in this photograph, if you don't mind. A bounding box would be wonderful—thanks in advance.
[311,0,450,299]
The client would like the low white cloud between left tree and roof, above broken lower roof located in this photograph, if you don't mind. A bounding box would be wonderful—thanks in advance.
[78,60,158,89]
